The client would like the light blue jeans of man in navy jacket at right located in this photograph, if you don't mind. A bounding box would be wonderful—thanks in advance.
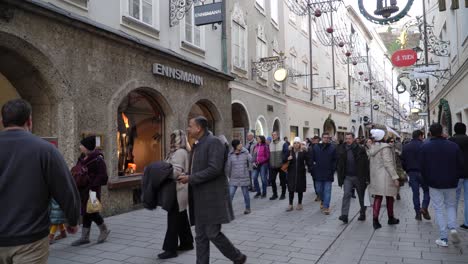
[430,188,457,239]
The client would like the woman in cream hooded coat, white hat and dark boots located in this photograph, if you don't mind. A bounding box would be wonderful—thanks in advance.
[367,129,400,229]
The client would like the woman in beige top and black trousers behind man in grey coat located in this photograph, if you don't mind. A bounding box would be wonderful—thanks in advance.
[158,130,193,259]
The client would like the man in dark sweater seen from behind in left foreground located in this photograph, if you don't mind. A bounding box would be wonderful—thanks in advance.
[0,99,80,264]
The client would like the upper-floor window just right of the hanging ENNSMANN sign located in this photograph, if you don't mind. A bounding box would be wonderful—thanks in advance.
[232,21,247,70]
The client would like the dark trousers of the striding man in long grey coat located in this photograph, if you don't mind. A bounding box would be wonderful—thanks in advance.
[195,224,242,264]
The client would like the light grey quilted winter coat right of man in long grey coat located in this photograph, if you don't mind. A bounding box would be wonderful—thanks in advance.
[225,148,252,187]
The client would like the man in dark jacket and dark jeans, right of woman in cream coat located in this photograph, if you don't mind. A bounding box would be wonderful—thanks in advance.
[401,130,431,221]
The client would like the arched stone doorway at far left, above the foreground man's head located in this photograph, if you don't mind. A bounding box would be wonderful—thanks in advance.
[0,47,54,136]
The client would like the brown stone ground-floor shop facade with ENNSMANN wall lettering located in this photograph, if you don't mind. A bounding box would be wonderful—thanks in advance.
[0,1,232,215]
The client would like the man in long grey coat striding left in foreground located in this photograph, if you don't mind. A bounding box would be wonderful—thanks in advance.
[178,116,247,264]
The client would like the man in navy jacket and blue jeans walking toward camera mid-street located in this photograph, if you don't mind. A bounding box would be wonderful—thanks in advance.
[309,133,336,215]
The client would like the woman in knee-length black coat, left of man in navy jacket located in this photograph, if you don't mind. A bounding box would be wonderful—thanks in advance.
[286,137,308,212]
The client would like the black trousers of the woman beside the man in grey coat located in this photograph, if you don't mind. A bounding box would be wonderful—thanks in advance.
[163,206,193,252]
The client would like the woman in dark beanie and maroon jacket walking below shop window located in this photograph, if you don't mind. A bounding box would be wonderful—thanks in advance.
[72,136,110,246]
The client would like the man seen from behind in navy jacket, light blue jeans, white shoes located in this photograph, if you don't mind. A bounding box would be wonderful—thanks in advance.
[419,123,463,247]
